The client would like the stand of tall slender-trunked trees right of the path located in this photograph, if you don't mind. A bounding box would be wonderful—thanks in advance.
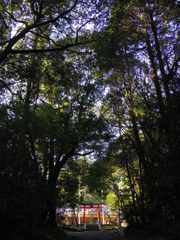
[93,1,180,234]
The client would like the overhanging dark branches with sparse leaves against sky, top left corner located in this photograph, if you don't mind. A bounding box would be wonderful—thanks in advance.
[0,0,109,64]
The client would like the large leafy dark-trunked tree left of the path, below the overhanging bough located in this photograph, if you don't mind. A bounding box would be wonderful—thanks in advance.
[1,35,112,236]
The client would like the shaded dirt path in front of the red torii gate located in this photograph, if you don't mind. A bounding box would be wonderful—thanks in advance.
[67,231,123,240]
